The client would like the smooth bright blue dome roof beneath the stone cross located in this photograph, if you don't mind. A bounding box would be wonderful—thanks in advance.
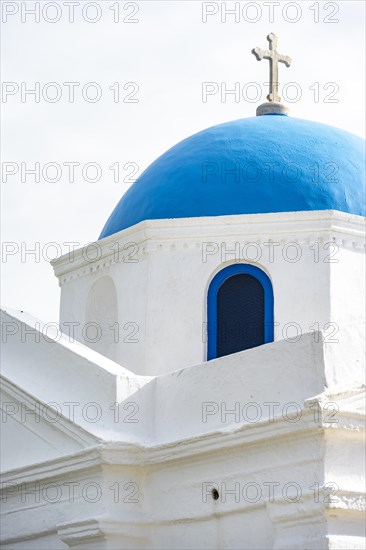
[100,115,365,238]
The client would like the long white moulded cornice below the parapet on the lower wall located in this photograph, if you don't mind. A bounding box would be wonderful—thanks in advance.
[1,407,363,487]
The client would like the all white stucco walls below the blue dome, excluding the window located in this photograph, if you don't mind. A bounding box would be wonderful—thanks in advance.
[1,208,365,550]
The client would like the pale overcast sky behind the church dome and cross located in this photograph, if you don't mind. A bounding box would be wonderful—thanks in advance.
[0,0,365,322]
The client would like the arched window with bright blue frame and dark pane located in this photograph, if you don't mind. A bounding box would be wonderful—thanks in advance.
[207,264,273,360]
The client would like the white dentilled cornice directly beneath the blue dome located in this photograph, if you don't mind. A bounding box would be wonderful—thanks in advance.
[51,210,365,285]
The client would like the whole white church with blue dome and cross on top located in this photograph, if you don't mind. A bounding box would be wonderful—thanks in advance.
[1,35,366,550]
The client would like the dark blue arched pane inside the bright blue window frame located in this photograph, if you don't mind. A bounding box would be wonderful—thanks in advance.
[216,273,264,357]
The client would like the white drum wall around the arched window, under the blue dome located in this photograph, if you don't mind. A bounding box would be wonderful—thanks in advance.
[53,211,364,383]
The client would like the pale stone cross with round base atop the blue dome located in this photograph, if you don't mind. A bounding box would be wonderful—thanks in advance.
[252,32,291,116]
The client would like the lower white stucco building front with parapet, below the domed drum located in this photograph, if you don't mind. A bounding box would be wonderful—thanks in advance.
[1,313,365,550]
